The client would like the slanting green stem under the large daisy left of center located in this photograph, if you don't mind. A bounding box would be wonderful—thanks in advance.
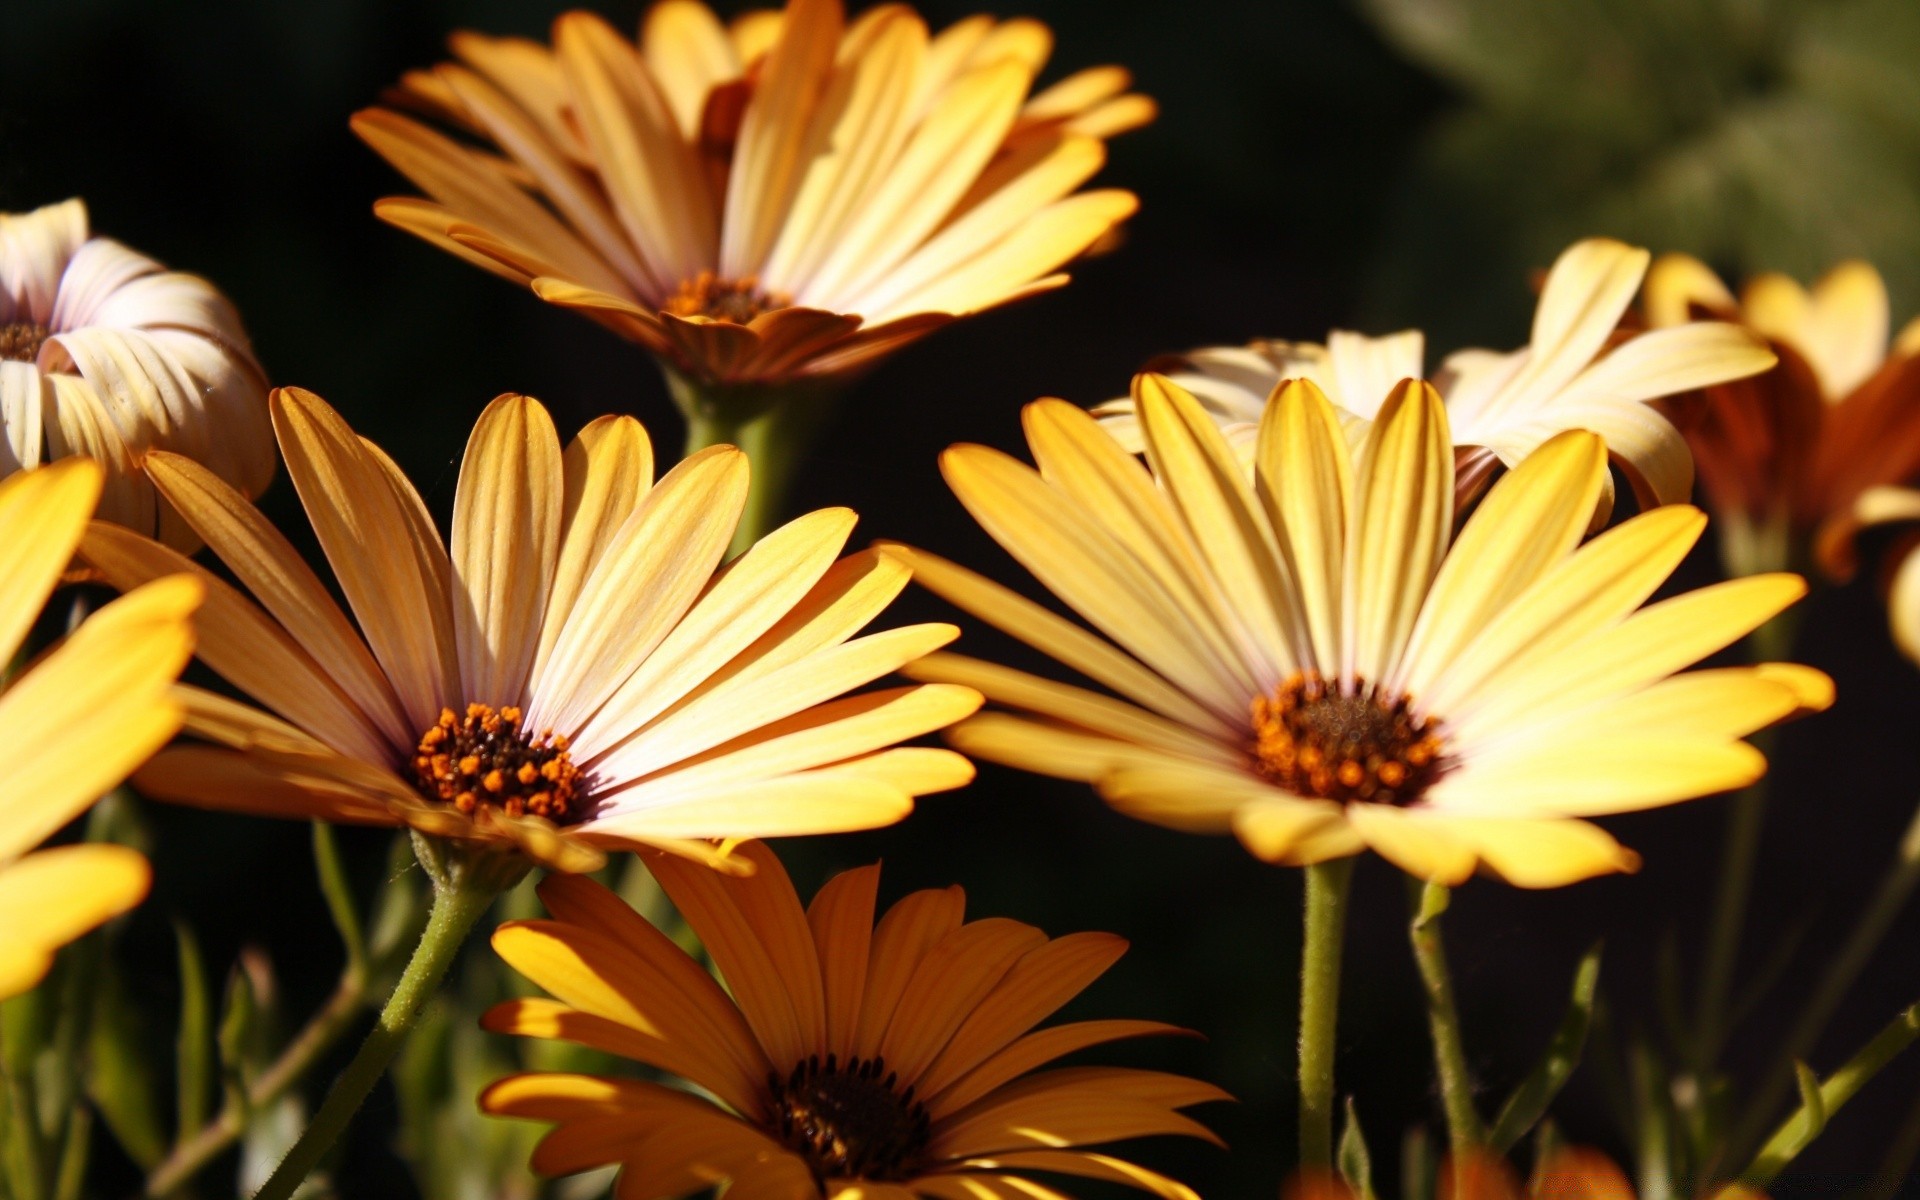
[253,856,501,1200]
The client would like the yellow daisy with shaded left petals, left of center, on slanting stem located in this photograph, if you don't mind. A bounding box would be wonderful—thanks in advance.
[81,390,979,870]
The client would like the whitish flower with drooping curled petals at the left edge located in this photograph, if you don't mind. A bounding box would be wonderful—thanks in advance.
[0,200,275,551]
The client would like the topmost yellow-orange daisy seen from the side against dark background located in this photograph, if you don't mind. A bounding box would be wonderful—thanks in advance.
[353,0,1154,388]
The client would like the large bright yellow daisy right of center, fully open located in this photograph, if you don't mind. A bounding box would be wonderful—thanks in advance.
[893,374,1832,887]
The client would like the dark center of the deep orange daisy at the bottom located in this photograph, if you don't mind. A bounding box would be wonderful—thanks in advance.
[766,1054,931,1183]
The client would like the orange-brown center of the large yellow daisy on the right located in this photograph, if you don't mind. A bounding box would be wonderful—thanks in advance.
[1252,670,1442,804]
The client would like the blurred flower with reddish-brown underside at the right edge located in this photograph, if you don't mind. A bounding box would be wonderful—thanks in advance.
[1645,253,1920,576]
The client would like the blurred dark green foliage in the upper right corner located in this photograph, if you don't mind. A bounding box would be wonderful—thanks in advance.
[1361,0,1920,346]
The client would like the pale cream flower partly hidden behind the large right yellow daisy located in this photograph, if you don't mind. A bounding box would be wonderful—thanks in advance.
[1094,238,1772,507]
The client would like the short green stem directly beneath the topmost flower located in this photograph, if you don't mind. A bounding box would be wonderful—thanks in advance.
[666,369,833,555]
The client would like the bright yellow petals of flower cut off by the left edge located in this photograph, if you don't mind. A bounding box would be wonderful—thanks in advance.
[0,459,200,1000]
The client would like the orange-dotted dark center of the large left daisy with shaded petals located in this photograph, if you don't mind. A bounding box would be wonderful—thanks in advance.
[413,705,584,826]
